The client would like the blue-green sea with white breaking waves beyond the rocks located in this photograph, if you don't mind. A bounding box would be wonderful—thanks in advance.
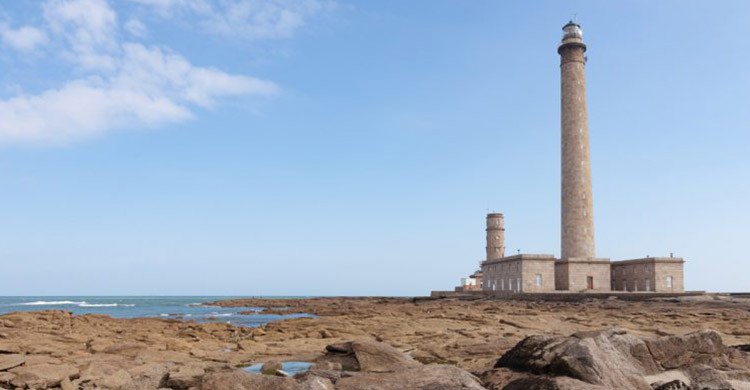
[0,296,315,327]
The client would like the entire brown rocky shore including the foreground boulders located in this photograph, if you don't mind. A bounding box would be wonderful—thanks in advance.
[0,296,750,390]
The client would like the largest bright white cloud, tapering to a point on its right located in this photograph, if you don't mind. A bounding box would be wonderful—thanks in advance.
[0,0,278,144]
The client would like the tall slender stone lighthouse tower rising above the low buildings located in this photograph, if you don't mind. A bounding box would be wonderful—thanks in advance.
[557,21,596,260]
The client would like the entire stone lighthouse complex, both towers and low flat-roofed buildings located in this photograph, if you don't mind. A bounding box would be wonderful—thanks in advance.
[480,22,684,293]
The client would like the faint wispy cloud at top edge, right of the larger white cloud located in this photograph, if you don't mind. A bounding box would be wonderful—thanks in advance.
[130,0,332,39]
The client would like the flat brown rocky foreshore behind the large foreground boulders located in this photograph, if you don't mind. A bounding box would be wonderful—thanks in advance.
[0,297,750,388]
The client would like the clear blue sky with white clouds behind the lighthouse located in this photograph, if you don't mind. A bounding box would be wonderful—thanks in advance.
[0,0,750,295]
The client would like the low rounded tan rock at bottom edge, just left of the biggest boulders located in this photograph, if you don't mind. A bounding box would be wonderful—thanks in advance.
[336,364,485,390]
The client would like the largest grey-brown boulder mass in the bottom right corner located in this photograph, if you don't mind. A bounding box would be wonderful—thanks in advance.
[494,328,750,390]
